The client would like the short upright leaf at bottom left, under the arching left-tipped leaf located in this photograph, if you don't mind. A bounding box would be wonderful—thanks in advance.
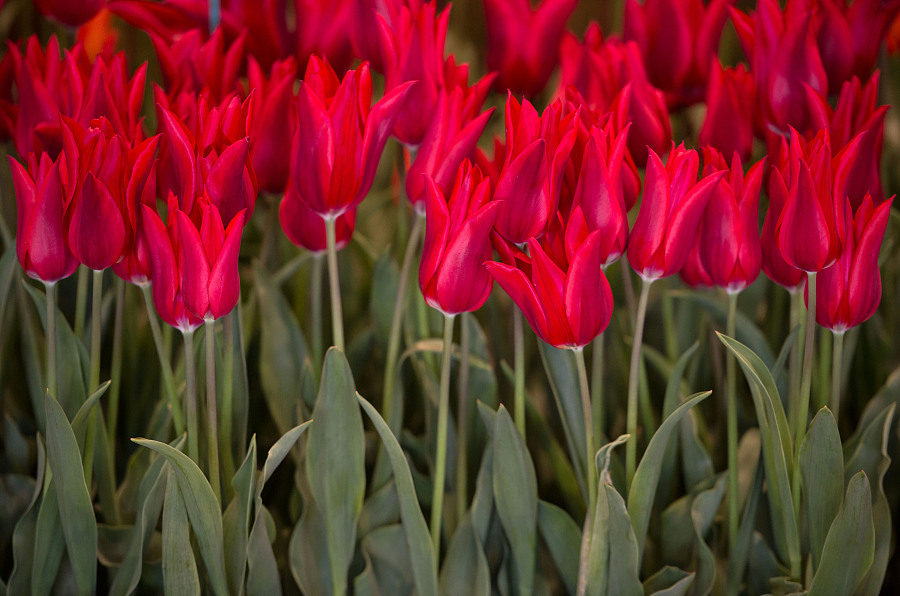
[162,465,202,596]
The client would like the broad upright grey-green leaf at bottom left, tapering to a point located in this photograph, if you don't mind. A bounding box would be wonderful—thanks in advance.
[44,393,97,594]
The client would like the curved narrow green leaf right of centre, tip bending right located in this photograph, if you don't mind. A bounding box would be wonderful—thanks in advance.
[628,391,712,558]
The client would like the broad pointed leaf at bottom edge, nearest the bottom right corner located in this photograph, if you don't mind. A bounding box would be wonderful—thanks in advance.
[809,472,875,596]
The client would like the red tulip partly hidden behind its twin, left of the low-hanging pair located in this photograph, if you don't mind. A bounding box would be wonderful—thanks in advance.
[141,194,203,333]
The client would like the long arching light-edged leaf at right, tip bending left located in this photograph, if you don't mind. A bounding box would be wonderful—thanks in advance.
[716,333,800,576]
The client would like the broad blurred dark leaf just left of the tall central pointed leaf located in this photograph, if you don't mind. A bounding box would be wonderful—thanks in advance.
[253,264,309,434]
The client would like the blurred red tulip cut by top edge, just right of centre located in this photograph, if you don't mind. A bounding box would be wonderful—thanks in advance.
[484,0,578,97]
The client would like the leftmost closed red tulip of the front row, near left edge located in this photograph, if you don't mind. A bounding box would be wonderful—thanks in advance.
[9,153,78,283]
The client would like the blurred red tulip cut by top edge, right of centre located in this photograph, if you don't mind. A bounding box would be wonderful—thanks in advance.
[623,0,734,106]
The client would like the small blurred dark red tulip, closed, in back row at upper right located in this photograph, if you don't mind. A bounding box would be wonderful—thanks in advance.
[699,60,756,160]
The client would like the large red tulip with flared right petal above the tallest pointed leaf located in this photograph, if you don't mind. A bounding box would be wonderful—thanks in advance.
[291,57,412,217]
